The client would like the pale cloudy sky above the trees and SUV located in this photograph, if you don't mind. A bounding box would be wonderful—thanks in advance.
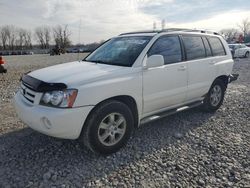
[0,0,250,44]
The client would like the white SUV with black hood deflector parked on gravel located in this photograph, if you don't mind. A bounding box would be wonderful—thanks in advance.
[15,29,237,154]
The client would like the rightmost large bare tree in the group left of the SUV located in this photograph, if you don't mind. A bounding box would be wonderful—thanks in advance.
[53,25,71,49]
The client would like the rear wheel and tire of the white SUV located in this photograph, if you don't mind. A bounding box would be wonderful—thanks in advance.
[202,79,226,112]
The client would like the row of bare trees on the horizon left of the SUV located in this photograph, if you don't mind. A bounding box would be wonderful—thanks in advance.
[0,25,71,51]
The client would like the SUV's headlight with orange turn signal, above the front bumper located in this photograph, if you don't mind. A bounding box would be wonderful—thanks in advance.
[40,89,77,108]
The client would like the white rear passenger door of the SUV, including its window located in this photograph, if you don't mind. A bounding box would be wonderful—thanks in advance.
[182,35,216,101]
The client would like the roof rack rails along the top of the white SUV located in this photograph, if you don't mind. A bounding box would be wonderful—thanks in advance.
[120,28,220,36]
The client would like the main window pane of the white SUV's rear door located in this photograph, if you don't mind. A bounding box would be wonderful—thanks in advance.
[182,36,206,60]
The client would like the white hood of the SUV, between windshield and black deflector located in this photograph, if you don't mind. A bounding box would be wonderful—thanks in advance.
[28,61,125,86]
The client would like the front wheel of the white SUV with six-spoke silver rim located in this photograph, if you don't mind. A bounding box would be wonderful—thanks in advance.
[79,100,134,154]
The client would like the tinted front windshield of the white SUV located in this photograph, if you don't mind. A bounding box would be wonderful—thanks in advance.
[84,36,152,67]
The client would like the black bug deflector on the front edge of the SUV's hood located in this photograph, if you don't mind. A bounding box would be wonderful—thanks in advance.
[21,74,67,92]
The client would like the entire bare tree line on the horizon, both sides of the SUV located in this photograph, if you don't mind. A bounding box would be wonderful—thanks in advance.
[0,18,250,51]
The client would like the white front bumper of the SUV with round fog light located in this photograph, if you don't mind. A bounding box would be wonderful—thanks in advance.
[14,92,93,139]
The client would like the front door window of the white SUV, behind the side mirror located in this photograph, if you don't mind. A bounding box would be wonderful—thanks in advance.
[148,36,182,64]
